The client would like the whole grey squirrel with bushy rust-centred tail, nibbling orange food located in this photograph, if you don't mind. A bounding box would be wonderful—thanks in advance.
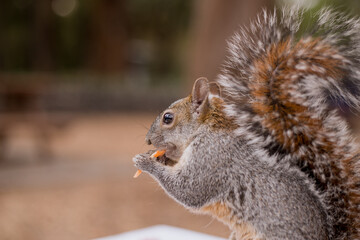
[133,8,360,240]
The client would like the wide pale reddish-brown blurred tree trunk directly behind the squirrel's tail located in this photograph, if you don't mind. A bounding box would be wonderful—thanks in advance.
[187,0,274,85]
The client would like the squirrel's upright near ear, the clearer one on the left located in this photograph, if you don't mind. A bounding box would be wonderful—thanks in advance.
[191,77,210,112]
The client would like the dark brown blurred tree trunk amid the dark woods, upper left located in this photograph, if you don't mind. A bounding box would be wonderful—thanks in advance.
[87,0,129,72]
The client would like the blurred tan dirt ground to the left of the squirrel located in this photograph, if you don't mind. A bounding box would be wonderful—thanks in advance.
[0,114,229,240]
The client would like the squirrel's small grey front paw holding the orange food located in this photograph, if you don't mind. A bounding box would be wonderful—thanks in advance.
[133,151,163,175]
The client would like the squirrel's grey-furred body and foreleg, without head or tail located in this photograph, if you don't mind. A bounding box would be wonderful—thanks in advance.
[134,123,327,239]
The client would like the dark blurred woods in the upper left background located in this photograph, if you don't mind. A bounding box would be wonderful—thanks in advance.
[0,0,192,82]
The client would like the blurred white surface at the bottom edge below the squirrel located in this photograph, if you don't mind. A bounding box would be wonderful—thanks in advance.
[97,225,225,240]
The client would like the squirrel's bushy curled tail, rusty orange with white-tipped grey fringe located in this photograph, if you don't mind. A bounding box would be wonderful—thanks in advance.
[217,8,360,239]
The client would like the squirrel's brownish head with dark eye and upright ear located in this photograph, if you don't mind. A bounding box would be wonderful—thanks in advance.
[146,78,233,161]
